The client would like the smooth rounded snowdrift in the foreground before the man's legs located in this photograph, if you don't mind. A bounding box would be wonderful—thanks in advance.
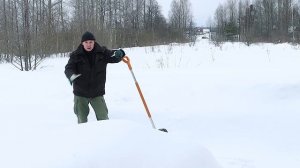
[0,120,219,168]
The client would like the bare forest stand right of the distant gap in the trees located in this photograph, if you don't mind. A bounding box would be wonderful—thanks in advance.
[210,0,300,44]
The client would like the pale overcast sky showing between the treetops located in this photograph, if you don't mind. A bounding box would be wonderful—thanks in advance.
[157,0,227,26]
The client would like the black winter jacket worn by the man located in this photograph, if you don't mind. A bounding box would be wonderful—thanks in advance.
[65,42,122,98]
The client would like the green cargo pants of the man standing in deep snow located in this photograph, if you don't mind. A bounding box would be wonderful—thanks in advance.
[74,95,108,124]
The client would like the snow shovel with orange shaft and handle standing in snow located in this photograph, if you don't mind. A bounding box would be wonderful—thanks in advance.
[123,56,168,132]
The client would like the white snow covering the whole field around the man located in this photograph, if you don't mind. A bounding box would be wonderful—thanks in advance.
[0,39,300,168]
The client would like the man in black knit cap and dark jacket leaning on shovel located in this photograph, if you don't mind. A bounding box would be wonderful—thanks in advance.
[65,32,125,123]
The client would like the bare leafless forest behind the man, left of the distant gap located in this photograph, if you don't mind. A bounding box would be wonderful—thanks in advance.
[0,0,194,71]
